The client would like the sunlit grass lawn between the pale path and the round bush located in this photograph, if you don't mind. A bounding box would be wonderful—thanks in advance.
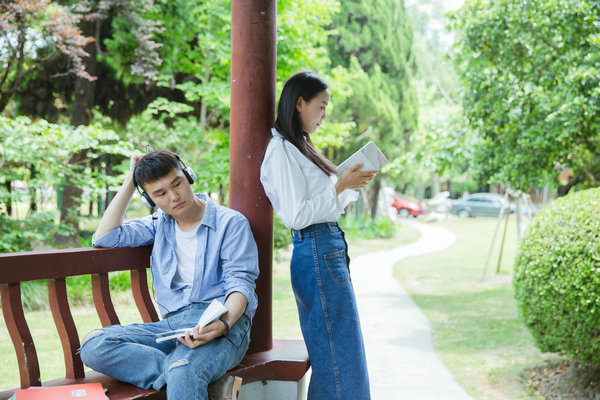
[394,218,557,400]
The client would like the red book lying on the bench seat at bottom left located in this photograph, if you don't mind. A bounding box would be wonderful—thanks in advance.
[15,382,107,400]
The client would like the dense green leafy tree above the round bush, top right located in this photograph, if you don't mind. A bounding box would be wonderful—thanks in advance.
[452,0,600,189]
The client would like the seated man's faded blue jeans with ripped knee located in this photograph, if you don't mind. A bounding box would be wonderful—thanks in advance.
[81,303,250,400]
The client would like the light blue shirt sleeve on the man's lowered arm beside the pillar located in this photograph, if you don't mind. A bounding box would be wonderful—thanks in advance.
[221,214,259,317]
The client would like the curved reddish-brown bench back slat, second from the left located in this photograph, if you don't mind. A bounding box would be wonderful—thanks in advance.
[48,278,85,379]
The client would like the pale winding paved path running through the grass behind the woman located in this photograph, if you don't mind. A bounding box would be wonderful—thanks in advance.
[350,221,472,400]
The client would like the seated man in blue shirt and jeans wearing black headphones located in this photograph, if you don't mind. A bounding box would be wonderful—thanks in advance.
[81,151,258,400]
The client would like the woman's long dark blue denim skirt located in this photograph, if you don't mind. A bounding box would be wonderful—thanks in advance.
[291,222,370,400]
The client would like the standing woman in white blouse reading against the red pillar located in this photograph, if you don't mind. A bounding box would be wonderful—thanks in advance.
[260,72,377,400]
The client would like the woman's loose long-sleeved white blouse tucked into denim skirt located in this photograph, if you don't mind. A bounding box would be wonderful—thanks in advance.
[260,129,358,230]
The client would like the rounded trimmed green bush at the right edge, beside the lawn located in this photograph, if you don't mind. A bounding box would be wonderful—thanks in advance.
[514,189,600,364]
